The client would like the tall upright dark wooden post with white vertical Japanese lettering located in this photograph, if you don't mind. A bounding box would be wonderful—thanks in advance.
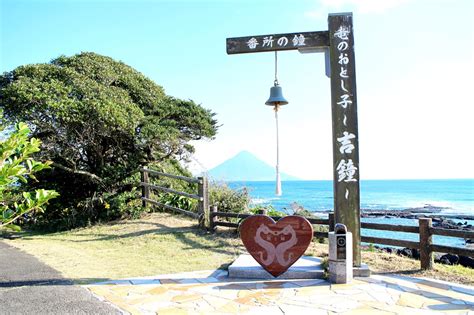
[328,13,361,266]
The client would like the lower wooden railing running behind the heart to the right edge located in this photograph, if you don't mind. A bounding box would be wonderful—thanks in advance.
[209,207,474,269]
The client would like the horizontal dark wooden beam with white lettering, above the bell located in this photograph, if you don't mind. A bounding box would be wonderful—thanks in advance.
[227,31,329,55]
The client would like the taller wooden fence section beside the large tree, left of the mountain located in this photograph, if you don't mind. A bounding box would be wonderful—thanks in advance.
[140,167,209,225]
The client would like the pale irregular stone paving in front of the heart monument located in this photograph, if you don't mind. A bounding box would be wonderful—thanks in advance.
[86,270,474,315]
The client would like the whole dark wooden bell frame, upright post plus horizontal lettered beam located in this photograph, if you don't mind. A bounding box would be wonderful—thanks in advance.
[226,13,361,266]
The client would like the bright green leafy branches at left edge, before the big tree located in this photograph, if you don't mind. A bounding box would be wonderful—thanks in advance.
[0,119,58,230]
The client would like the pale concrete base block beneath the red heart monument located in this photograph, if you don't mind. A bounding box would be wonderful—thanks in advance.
[229,254,324,279]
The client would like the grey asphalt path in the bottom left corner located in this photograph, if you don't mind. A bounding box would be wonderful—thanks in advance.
[0,241,121,315]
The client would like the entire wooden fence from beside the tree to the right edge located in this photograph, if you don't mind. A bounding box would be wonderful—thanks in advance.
[140,167,474,269]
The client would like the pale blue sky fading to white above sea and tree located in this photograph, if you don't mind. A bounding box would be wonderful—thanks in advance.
[0,0,474,179]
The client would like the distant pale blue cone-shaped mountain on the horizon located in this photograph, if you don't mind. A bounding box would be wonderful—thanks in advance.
[208,150,298,181]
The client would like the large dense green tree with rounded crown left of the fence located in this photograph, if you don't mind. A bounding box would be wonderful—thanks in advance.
[0,53,217,227]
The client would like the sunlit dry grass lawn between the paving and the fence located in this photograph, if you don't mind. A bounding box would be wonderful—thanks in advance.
[5,213,474,285]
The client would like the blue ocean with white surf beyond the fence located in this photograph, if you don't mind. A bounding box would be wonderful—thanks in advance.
[228,179,474,247]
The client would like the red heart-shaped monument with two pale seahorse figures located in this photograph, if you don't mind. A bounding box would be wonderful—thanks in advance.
[239,215,313,277]
